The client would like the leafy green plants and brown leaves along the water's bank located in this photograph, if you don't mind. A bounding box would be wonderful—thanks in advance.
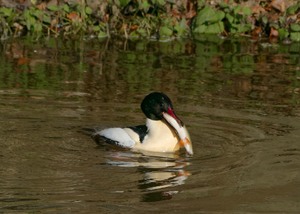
[0,0,300,41]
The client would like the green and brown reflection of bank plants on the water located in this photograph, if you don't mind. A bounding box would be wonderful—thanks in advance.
[0,38,300,110]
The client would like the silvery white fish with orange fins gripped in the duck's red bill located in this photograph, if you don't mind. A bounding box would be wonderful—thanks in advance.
[163,112,193,155]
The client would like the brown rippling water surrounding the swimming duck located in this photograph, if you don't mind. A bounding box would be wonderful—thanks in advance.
[0,38,300,213]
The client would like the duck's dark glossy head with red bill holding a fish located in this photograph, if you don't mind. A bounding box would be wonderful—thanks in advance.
[141,92,193,155]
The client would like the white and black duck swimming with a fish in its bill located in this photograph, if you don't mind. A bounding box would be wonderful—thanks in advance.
[92,92,193,155]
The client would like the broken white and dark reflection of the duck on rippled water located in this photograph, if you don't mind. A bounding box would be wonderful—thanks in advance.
[106,151,190,201]
